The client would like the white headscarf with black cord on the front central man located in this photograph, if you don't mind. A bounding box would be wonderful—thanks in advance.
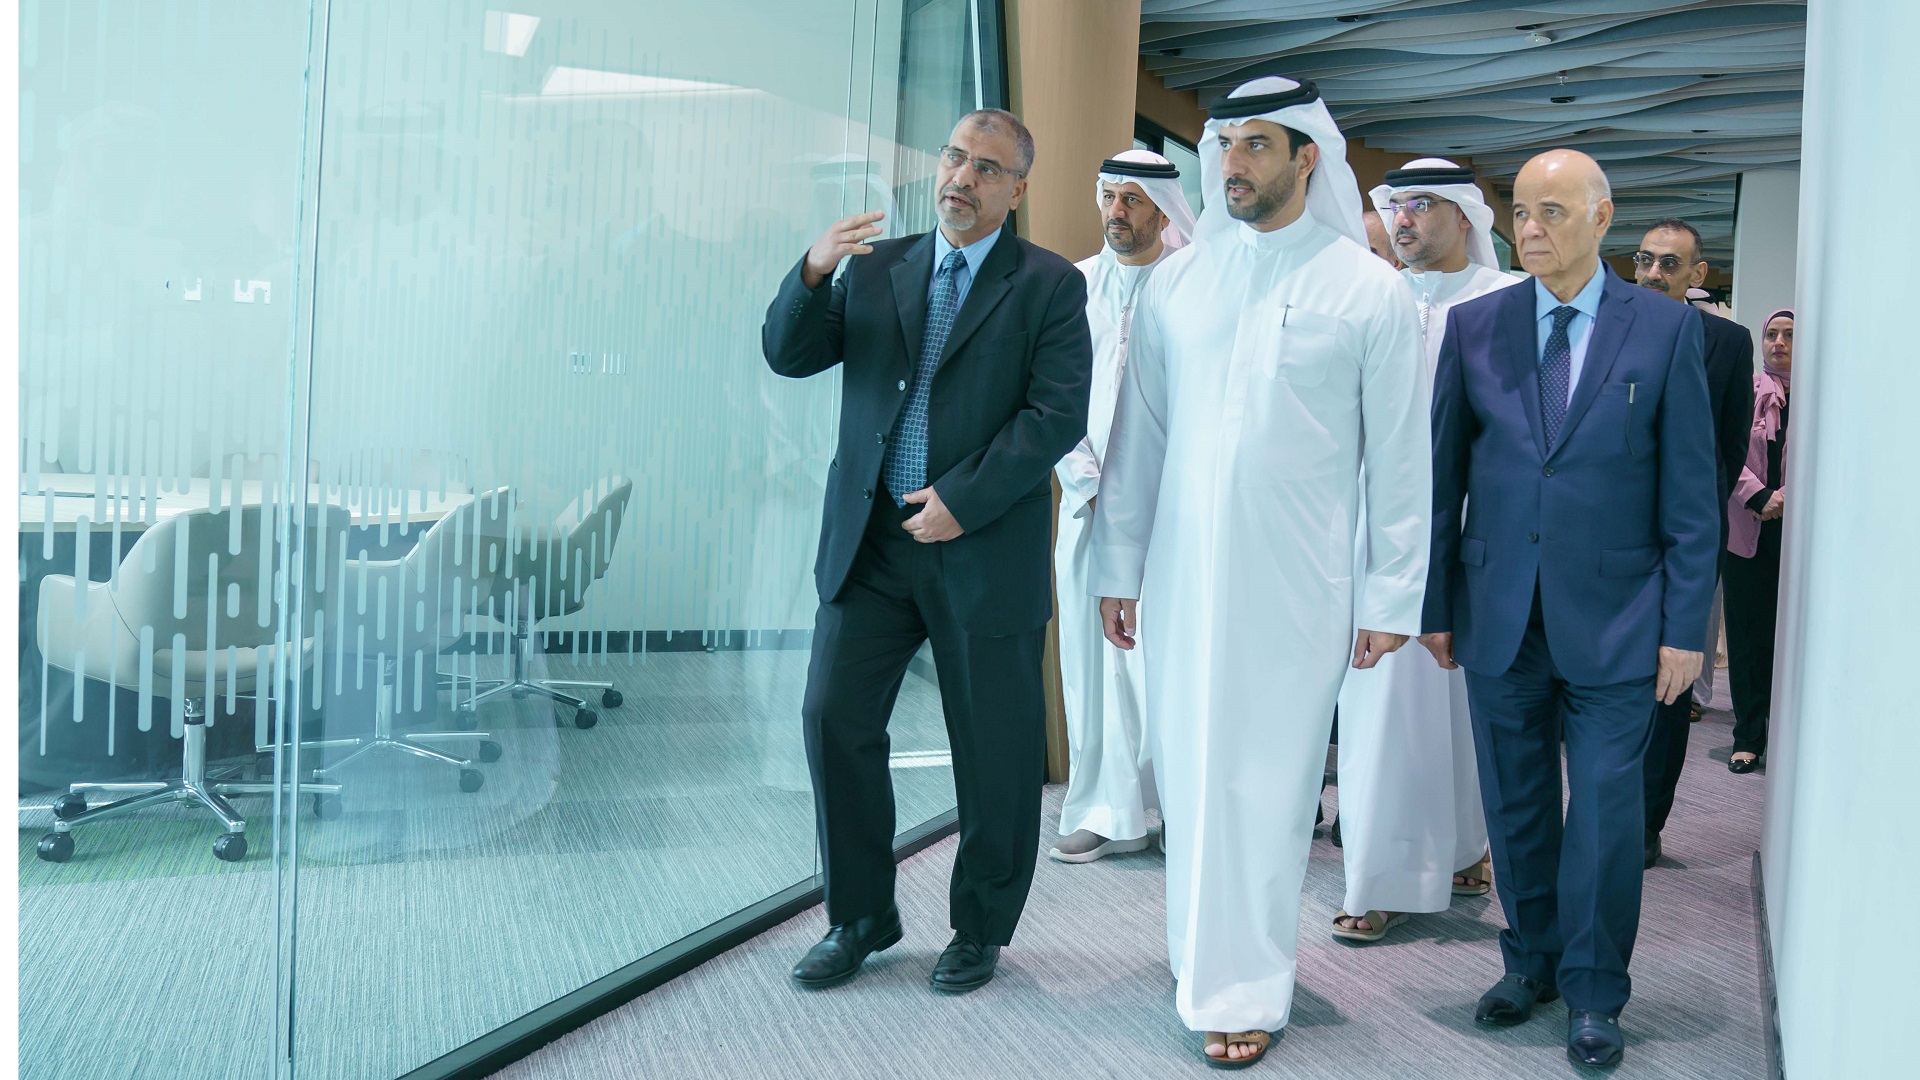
[1194,75,1367,248]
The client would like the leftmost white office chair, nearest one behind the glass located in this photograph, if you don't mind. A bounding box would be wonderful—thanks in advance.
[36,505,353,863]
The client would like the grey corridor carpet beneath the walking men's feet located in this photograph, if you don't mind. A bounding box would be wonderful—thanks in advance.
[497,668,1766,1080]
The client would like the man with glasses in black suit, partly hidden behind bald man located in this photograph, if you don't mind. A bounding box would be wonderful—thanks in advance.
[1634,217,1753,869]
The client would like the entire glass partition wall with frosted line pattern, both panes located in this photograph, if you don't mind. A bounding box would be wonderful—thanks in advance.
[19,0,998,1080]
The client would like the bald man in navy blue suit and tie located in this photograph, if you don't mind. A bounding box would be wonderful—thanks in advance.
[1421,150,1720,1068]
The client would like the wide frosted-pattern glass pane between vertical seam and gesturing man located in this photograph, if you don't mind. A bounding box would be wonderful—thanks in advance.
[294,0,973,1078]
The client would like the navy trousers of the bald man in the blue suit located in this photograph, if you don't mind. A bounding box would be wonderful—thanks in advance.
[1467,592,1653,1015]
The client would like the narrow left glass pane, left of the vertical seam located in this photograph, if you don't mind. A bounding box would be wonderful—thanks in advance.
[15,0,314,1080]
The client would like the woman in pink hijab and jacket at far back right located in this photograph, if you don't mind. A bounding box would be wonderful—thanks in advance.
[1720,309,1793,773]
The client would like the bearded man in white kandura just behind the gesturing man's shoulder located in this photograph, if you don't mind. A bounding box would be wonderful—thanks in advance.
[1046,150,1194,863]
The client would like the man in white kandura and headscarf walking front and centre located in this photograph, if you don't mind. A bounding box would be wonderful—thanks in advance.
[1092,77,1432,1068]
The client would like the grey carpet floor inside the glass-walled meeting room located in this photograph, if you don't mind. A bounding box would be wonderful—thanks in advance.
[19,651,954,1080]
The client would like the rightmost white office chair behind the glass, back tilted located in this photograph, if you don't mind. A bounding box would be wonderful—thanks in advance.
[463,477,634,728]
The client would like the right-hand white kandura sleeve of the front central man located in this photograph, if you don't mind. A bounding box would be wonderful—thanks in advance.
[1354,275,1434,636]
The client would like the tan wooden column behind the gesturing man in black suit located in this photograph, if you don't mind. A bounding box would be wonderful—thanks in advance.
[1006,0,1140,772]
